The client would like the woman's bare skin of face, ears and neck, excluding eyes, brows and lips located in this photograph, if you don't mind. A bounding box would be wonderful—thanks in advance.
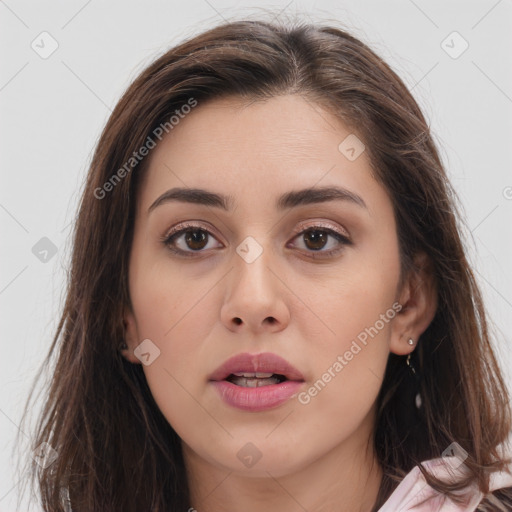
[124,95,436,512]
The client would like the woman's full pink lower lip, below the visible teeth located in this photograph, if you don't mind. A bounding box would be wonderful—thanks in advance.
[211,380,304,412]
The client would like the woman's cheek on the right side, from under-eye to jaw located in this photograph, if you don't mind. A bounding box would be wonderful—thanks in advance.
[290,239,400,424]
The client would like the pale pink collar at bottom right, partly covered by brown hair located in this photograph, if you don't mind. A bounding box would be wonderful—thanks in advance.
[378,457,512,512]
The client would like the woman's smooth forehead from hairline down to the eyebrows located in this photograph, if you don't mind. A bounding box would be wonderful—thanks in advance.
[139,95,385,216]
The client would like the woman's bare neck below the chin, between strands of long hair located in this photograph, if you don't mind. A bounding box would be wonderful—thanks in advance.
[182,414,382,512]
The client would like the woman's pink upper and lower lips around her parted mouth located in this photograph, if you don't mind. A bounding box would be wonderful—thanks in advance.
[210,352,304,412]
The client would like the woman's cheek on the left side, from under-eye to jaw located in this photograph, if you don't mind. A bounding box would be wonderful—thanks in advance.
[130,261,222,437]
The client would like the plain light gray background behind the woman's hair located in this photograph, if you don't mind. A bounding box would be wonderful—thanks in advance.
[0,0,512,511]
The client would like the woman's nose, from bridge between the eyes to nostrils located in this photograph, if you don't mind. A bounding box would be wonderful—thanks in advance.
[221,244,290,334]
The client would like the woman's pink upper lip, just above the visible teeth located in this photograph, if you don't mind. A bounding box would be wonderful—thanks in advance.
[210,352,304,381]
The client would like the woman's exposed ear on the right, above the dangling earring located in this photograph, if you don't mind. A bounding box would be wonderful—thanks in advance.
[390,252,437,355]
